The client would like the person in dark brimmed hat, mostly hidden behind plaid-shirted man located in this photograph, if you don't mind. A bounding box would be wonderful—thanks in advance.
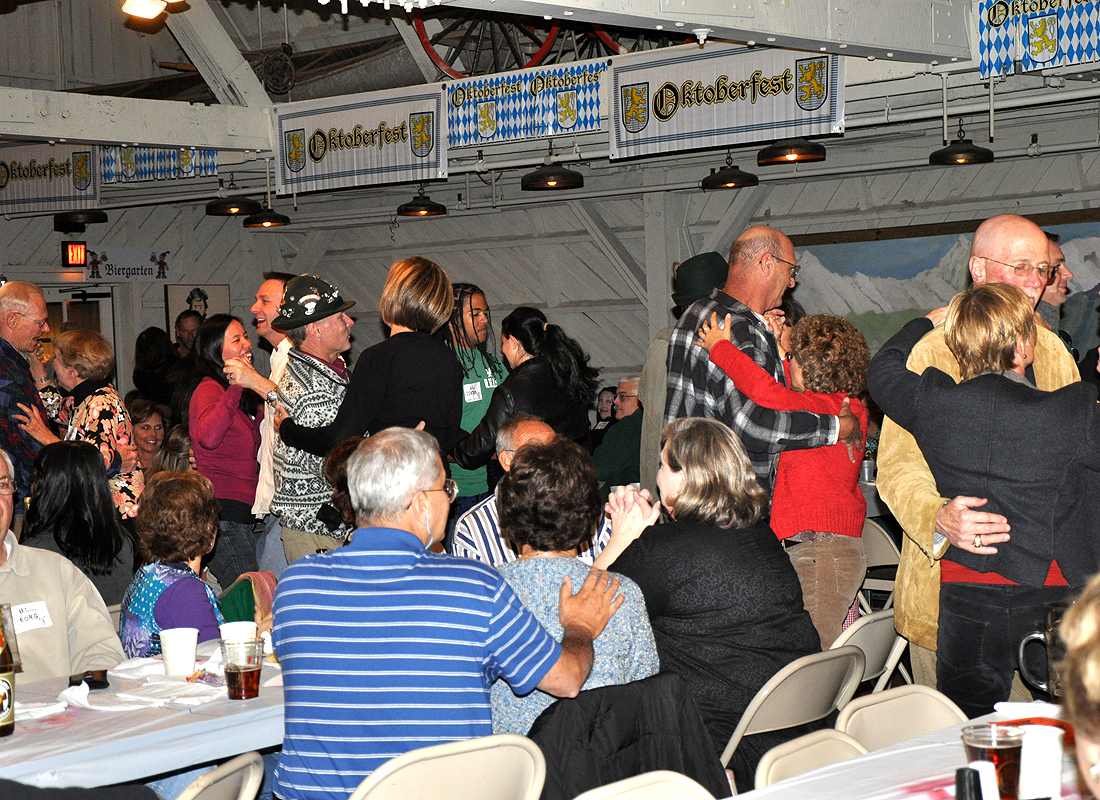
[638,250,729,497]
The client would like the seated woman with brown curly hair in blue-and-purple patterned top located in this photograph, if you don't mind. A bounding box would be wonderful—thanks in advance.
[119,471,226,658]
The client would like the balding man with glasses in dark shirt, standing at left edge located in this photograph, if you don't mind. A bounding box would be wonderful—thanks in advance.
[0,281,50,533]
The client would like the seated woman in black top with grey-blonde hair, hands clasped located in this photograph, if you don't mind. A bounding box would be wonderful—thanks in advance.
[595,417,824,791]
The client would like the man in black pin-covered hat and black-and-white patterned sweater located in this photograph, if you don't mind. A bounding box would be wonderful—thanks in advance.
[271,275,355,563]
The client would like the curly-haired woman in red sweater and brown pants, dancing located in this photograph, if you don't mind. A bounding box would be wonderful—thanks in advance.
[696,315,870,649]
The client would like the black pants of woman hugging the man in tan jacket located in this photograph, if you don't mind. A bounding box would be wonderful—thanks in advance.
[936,583,1079,717]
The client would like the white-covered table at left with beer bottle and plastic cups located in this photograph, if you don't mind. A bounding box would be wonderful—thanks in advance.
[0,669,283,788]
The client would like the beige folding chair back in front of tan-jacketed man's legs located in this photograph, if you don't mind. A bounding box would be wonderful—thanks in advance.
[836,683,967,750]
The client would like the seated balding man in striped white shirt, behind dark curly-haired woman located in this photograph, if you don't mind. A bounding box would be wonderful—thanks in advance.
[451,414,612,567]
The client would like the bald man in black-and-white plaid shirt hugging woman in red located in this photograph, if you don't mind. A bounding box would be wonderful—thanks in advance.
[664,226,860,494]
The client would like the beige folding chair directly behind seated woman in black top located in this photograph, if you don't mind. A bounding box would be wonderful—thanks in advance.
[722,645,866,767]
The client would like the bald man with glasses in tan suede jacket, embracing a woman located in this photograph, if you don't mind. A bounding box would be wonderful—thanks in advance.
[878,215,1078,687]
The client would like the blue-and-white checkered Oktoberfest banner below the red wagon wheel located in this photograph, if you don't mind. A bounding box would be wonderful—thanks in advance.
[444,61,607,147]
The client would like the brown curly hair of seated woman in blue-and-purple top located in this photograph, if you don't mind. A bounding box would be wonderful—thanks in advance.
[134,470,220,563]
